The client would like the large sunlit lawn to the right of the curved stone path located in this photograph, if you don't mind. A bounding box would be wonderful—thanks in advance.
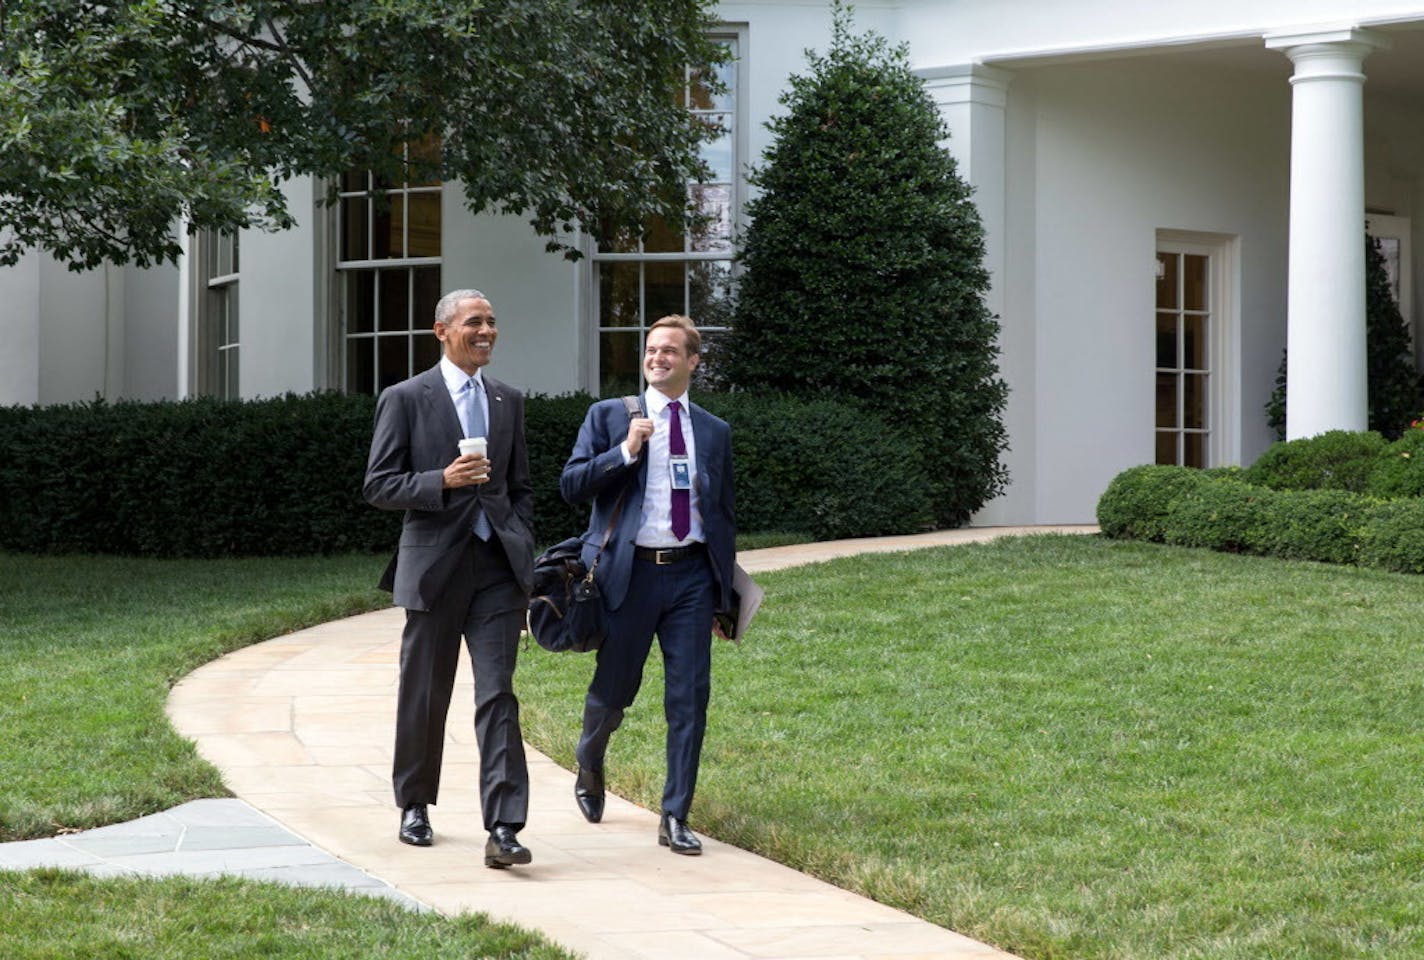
[518,537,1424,960]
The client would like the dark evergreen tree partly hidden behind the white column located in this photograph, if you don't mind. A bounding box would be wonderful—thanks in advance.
[1266,236,1420,440]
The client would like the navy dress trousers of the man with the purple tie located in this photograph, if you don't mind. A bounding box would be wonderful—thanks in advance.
[577,554,713,820]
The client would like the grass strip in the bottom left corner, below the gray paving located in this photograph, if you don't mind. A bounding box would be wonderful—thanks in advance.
[0,870,572,960]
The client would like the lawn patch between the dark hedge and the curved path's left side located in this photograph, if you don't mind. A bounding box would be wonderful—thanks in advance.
[0,554,390,840]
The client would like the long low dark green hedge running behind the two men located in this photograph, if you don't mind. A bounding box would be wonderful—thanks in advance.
[0,393,930,557]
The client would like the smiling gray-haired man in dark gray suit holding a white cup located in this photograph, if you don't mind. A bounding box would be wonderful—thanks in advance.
[365,289,534,867]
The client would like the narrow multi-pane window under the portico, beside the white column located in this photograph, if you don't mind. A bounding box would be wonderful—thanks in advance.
[1156,248,1215,467]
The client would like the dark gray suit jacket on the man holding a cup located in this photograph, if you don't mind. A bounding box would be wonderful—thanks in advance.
[362,363,534,610]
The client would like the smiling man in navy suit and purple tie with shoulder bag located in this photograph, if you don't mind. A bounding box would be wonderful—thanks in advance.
[560,316,736,855]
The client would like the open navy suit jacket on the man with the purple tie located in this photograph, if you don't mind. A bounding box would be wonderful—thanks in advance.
[558,399,736,612]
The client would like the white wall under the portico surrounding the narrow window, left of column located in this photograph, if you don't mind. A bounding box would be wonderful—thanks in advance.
[994,63,1289,523]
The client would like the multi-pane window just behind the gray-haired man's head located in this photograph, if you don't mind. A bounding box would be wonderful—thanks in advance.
[336,147,440,393]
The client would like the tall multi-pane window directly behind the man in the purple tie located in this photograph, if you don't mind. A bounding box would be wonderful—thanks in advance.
[591,37,740,396]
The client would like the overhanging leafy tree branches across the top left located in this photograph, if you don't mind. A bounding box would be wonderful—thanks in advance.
[0,0,723,269]
